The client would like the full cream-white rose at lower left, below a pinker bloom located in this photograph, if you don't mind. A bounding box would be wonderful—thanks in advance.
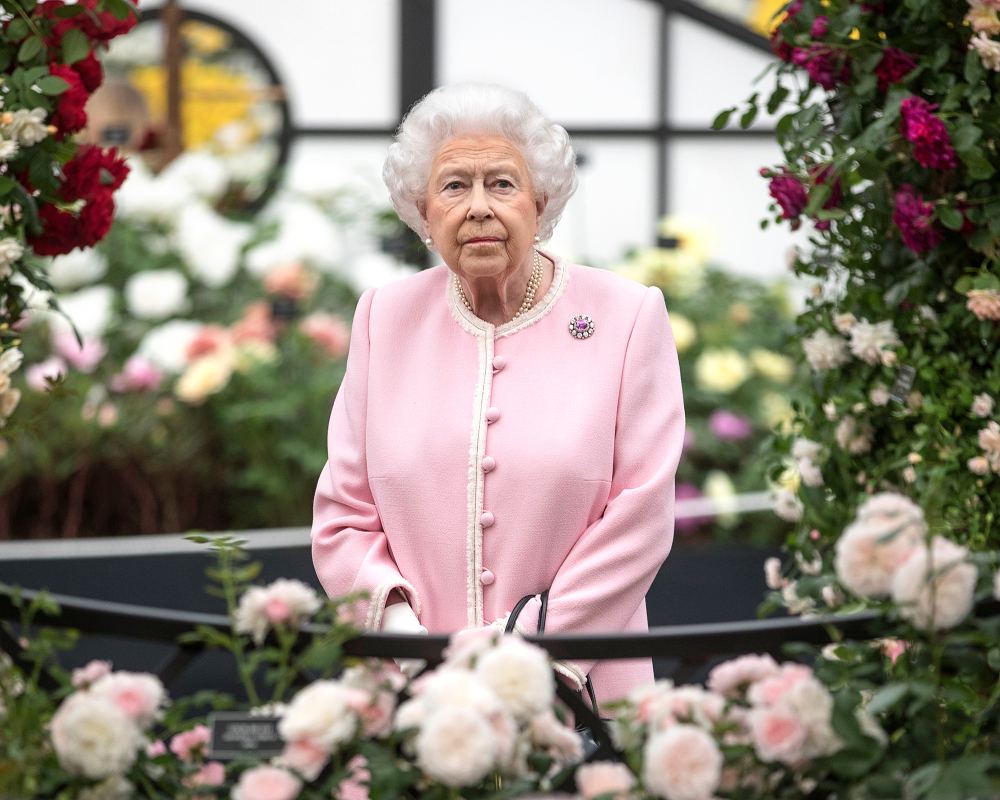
[50,692,143,778]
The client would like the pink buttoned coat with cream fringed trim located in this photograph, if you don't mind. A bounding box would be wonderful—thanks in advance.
[312,253,684,701]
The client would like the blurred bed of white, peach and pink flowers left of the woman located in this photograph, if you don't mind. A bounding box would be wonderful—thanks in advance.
[0,152,409,536]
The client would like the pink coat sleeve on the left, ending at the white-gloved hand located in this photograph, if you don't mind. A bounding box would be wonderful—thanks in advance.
[312,289,420,630]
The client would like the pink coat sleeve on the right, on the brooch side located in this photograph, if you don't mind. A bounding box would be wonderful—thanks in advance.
[519,287,684,684]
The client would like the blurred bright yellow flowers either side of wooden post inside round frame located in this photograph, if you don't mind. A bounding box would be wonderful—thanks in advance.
[129,59,257,149]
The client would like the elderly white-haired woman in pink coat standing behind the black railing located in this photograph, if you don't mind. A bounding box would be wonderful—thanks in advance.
[312,85,684,700]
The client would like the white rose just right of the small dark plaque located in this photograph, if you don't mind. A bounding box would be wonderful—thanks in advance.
[278,680,358,752]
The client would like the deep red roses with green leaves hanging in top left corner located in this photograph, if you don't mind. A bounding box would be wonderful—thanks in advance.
[0,0,136,427]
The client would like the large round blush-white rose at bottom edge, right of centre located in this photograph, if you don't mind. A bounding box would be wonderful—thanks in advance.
[642,725,723,800]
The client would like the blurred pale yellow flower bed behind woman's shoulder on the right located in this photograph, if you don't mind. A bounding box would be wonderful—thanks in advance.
[616,217,797,546]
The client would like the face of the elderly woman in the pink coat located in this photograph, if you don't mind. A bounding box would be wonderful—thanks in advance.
[420,136,545,280]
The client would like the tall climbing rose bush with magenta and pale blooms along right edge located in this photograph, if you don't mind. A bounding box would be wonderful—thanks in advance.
[717,0,1000,798]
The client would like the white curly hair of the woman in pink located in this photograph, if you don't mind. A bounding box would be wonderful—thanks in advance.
[382,83,577,240]
